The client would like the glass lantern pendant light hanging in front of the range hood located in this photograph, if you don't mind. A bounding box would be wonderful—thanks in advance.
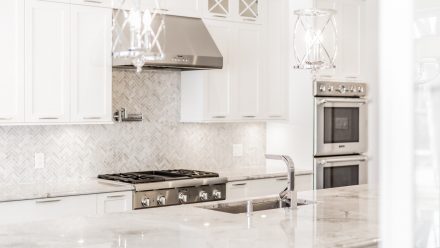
[112,0,165,73]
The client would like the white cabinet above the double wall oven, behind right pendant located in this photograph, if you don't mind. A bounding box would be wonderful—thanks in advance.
[316,0,366,80]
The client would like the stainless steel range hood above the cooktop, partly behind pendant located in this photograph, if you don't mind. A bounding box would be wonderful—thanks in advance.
[113,13,223,70]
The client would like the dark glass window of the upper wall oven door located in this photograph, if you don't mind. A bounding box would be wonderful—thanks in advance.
[324,107,359,144]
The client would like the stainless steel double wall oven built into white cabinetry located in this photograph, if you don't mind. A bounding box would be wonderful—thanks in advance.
[314,81,368,189]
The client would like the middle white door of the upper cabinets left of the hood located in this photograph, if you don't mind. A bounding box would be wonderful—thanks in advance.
[25,0,70,123]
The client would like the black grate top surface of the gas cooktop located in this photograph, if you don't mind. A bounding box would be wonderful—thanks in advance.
[98,169,219,184]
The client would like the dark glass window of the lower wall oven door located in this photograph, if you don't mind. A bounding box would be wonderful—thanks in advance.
[323,164,359,189]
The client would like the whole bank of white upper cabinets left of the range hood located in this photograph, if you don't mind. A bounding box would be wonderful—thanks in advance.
[0,0,112,125]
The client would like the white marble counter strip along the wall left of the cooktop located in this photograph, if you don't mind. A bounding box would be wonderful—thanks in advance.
[0,179,134,202]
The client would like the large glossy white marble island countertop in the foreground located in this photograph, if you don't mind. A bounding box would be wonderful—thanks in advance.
[0,185,378,248]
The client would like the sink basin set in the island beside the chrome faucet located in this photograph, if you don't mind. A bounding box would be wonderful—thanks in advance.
[200,198,314,214]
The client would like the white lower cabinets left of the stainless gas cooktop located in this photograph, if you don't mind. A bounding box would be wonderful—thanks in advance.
[0,191,132,224]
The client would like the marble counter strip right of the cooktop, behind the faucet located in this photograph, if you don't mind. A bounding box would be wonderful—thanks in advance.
[218,166,313,182]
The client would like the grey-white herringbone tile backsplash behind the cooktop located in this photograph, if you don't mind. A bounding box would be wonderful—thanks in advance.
[0,70,266,184]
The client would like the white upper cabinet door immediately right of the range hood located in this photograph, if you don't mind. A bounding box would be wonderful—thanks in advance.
[205,21,232,120]
